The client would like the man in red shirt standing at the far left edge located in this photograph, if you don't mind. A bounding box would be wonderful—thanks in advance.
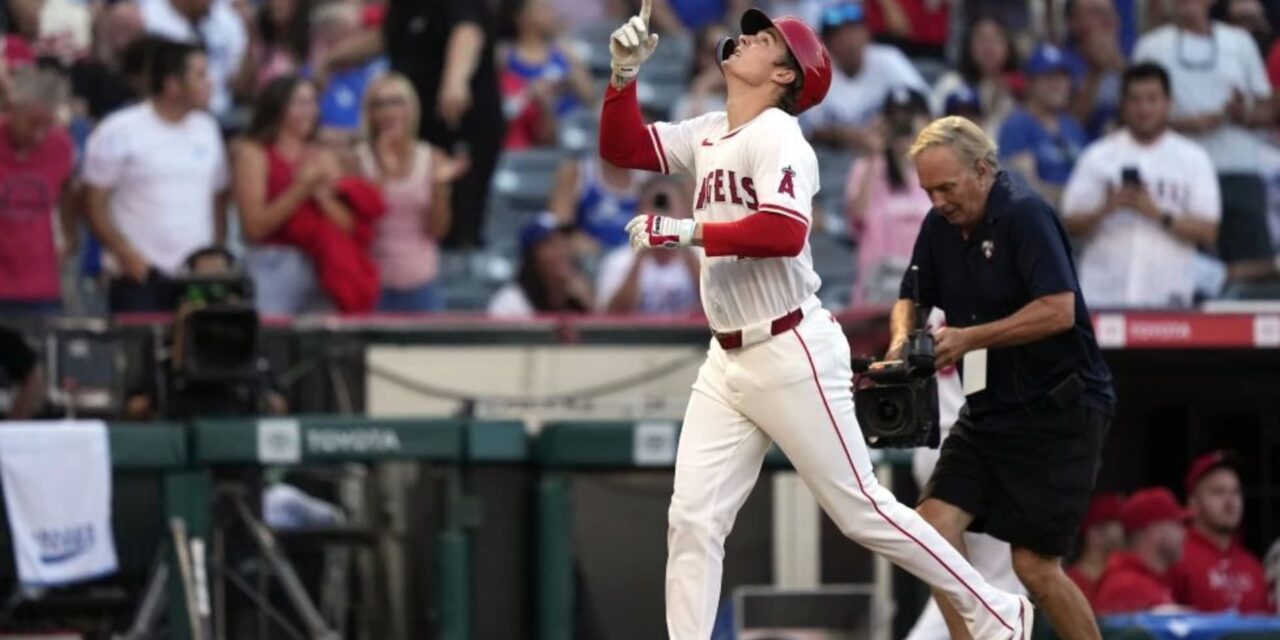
[0,67,74,315]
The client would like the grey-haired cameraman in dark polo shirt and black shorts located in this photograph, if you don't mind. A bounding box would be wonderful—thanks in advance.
[888,118,1115,640]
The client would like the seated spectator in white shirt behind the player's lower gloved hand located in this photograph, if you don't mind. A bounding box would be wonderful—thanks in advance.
[595,175,701,315]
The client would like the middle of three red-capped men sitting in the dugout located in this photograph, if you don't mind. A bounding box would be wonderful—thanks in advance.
[1094,488,1187,616]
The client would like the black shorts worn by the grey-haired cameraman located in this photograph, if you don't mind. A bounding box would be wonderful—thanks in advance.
[920,407,1111,557]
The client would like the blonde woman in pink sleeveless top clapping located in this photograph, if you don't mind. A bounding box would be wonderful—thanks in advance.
[356,73,467,312]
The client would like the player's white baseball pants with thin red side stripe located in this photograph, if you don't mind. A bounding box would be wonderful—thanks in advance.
[666,301,1021,640]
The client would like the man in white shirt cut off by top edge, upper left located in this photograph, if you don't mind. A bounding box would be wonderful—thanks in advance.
[138,0,248,118]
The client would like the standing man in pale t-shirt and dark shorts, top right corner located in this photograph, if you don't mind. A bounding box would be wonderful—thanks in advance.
[1133,0,1272,262]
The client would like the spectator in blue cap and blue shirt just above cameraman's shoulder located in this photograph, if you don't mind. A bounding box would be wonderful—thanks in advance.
[1000,45,1088,206]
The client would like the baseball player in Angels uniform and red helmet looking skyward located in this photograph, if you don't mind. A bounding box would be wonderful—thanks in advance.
[600,0,1033,640]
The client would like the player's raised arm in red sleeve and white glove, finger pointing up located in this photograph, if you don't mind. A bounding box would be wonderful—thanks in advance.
[599,0,667,173]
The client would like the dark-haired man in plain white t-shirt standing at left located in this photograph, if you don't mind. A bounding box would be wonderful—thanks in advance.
[83,42,228,311]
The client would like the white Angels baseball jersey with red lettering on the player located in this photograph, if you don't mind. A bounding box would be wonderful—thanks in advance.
[649,109,822,332]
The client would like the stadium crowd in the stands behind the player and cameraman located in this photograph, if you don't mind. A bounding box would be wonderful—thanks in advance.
[0,0,1280,316]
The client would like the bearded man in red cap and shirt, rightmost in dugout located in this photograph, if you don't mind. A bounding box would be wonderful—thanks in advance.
[1170,451,1274,613]
